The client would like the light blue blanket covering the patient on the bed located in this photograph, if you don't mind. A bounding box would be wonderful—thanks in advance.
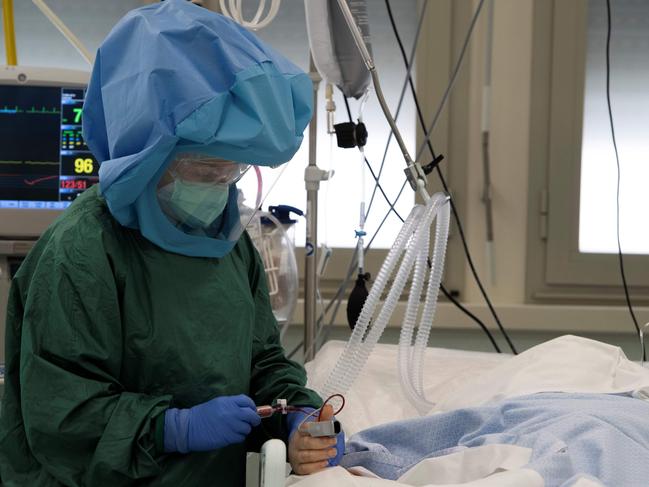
[341,393,649,487]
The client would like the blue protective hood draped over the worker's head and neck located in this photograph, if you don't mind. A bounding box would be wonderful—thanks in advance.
[83,0,312,257]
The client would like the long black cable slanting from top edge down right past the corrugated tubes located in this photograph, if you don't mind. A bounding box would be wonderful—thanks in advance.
[385,0,518,355]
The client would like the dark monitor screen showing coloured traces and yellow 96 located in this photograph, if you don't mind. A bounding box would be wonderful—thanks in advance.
[0,85,99,210]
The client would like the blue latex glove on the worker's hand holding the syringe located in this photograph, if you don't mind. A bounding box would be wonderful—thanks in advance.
[164,394,261,453]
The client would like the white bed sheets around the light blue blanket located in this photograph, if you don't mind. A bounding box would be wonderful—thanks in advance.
[254,336,649,487]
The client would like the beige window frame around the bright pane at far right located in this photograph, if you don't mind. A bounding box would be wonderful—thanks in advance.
[527,0,649,304]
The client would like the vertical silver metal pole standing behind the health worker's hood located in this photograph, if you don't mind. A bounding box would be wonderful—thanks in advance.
[304,57,324,362]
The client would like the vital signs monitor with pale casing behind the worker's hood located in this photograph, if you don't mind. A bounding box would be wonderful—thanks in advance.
[0,66,91,240]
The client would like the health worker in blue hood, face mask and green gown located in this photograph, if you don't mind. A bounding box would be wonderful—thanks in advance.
[0,0,343,487]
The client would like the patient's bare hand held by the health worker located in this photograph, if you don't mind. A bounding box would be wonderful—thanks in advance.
[288,405,337,475]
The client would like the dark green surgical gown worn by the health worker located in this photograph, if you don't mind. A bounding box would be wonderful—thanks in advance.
[0,188,321,487]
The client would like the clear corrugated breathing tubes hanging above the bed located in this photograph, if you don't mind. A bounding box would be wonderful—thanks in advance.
[321,193,449,404]
